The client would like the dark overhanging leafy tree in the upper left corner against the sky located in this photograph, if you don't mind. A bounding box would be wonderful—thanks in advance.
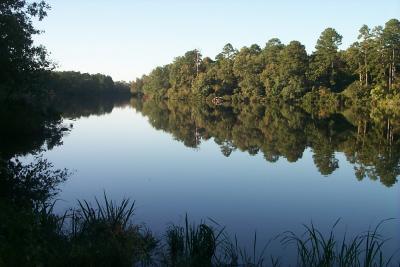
[0,0,51,99]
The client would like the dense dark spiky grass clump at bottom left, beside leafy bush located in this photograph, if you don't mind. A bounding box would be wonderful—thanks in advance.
[67,193,157,266]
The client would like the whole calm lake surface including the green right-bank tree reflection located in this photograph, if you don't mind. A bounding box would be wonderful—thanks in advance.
[17,100,400,260]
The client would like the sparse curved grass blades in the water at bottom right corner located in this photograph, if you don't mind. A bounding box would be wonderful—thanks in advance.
[282,219,394,267]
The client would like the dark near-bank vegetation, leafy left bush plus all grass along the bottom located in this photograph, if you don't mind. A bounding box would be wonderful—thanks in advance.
[0,158,400,267]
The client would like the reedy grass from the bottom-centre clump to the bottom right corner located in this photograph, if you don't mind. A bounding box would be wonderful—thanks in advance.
[159,215,399,267]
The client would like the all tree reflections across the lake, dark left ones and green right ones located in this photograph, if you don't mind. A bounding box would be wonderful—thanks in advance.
[0,96,400,186]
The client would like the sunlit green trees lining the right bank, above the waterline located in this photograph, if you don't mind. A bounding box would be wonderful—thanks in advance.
[131,19,400,114]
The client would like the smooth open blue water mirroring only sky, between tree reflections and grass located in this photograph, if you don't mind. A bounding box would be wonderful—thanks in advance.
[38,106,400,260]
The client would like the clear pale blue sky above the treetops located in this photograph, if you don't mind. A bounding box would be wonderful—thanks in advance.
[36,0,400,81]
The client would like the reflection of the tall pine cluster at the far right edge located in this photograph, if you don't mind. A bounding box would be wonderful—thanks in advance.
[340,110,400,186]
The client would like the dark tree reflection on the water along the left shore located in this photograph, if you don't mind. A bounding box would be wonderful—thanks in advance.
[0,96,129,159]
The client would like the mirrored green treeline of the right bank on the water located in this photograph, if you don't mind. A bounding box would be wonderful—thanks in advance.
[134,99,400,186]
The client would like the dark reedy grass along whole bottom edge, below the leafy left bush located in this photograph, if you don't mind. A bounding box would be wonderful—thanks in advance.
[0,194,399,267]
